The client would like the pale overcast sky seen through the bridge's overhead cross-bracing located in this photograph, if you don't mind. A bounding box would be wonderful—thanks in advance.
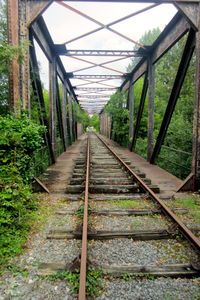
[33,1,177,113]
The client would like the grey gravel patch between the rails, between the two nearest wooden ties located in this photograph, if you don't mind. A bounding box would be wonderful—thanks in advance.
[88,239,198,266]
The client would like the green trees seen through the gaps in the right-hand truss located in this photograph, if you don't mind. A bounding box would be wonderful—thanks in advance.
[125,28,195,178]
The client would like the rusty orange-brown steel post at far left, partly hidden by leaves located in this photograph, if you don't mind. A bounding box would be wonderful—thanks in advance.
[7,0,20,112]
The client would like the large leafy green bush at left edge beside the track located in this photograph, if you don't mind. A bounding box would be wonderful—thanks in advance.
[0,114,44,265]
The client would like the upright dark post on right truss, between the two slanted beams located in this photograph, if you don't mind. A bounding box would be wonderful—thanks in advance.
[147,57,155,161]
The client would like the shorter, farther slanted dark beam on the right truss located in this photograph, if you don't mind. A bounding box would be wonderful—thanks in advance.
[130,71,148,151]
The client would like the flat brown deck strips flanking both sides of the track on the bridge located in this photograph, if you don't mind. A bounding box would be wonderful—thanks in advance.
[40,135,182,198]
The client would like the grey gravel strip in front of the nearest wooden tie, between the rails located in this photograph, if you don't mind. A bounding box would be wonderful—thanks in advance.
[96,278,200,300]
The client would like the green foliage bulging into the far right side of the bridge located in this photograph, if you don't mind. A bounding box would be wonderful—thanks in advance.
[105,92,129,146]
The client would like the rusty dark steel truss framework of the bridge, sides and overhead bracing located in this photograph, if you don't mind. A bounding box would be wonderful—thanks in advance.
[7,0,200,189]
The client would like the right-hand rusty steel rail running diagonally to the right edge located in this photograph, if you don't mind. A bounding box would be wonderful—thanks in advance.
[96,134,200,251]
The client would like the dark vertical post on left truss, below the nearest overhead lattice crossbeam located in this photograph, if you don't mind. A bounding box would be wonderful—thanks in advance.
[49,57,57,153]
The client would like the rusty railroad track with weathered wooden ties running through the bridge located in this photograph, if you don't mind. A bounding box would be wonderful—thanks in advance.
[48,134,200,300]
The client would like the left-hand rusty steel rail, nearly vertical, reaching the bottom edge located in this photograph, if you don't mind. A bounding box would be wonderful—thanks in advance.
[78,137,90,300]
